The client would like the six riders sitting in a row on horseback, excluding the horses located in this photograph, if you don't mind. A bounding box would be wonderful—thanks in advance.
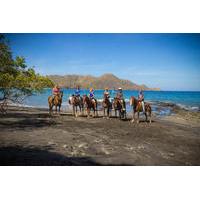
[52,85,145,112]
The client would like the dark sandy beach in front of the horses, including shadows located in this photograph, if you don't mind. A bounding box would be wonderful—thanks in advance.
[0,107,200,166]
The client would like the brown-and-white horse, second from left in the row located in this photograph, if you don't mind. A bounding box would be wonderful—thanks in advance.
[69,95,83,117]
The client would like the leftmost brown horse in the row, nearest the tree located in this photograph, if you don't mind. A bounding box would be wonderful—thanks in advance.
[48,91,63,114]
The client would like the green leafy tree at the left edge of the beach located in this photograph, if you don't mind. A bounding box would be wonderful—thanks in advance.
[0,35,53,112]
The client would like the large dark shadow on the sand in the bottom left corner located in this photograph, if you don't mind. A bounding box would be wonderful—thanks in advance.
[0,146,100,166]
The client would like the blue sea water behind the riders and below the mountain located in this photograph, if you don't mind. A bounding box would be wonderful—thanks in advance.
[19,89,200,115]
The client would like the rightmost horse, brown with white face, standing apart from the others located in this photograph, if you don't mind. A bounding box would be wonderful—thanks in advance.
[130,96,152,124]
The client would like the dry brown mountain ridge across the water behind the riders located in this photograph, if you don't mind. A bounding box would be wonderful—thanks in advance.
[47,74,160,90]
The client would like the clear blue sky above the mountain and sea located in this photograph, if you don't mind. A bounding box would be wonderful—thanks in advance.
[6,34,200,91]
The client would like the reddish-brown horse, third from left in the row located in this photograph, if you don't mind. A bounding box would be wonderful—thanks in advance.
[83,95,98,118]
